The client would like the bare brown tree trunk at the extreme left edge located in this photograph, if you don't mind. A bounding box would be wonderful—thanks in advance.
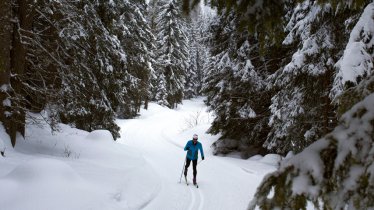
[0,0,13,146]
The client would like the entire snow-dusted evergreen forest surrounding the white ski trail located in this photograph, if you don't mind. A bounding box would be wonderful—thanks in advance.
[0,0,374,209]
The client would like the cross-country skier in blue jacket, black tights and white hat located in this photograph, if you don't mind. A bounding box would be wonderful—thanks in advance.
[184,134,204,185]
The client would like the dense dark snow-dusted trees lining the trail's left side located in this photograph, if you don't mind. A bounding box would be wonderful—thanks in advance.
[0,0,206,146]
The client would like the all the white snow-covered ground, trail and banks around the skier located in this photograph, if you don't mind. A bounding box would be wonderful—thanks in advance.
[0,98,278,210]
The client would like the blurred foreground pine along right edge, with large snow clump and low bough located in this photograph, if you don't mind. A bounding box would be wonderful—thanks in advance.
[249,2,374,210]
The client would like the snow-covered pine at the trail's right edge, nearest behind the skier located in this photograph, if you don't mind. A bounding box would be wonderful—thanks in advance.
[204,9,270,157]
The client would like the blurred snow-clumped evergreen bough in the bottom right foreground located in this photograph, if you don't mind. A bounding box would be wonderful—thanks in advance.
[249,73,374,209]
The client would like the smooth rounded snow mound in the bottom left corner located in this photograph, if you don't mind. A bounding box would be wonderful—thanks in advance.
[0,158,103,210]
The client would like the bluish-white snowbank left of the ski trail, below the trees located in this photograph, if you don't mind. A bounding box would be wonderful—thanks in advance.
[0,121,159,210]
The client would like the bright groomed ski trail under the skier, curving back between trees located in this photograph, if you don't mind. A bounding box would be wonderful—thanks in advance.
[117,98,274,210]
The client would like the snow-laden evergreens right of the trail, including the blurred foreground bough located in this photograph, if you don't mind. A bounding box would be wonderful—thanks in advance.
[183,0,374,209]
